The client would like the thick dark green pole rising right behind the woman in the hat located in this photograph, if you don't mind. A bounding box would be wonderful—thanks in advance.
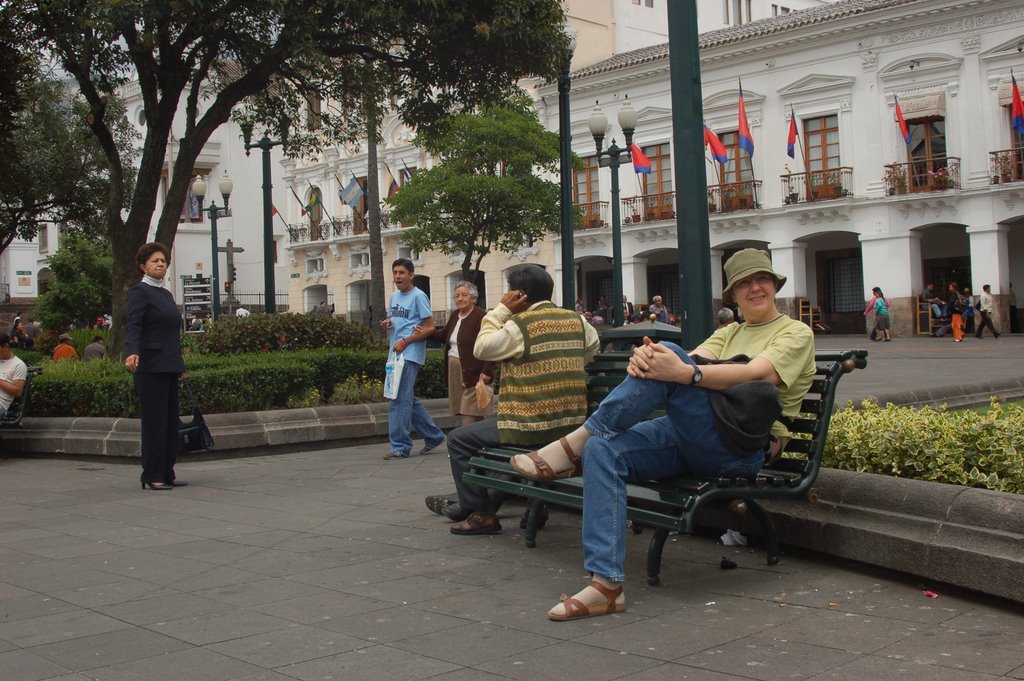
[667,2,708,348]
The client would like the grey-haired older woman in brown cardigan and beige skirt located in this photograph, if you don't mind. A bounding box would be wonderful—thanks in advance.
[431,282,495,426]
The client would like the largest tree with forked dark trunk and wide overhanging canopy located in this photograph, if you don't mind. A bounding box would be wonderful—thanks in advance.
[8,0,567,352]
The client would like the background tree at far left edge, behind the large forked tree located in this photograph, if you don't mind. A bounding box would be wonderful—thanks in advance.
[0,67,133,251]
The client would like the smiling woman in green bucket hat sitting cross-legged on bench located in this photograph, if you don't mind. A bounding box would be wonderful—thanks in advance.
[511,249,815,621]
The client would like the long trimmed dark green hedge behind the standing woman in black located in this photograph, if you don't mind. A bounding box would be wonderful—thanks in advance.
[29,348,447,417]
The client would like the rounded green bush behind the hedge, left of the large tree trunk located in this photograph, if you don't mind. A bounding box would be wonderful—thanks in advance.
[34,233,114,331]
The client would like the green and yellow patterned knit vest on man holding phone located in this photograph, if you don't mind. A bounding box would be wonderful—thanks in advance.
[498,303,587,444]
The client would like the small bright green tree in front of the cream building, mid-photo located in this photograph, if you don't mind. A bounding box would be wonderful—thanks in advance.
[391,96,559,281]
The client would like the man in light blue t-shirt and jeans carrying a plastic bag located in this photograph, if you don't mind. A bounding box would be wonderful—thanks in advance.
[381,258,444,461]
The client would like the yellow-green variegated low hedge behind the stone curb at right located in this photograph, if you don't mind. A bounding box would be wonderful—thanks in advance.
[823,397,1024,494]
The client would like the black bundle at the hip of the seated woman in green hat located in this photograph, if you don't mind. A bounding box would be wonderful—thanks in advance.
[693,354,782,457]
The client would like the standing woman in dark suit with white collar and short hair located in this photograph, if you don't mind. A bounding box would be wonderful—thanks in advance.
[125,243,187,490]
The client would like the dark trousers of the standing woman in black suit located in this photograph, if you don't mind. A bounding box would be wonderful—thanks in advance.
[134,373,181,482]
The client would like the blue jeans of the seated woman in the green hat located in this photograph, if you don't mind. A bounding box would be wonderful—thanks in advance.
[583,343,765,582]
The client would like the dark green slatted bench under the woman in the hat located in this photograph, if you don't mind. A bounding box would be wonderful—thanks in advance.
[463,350,867,586]
